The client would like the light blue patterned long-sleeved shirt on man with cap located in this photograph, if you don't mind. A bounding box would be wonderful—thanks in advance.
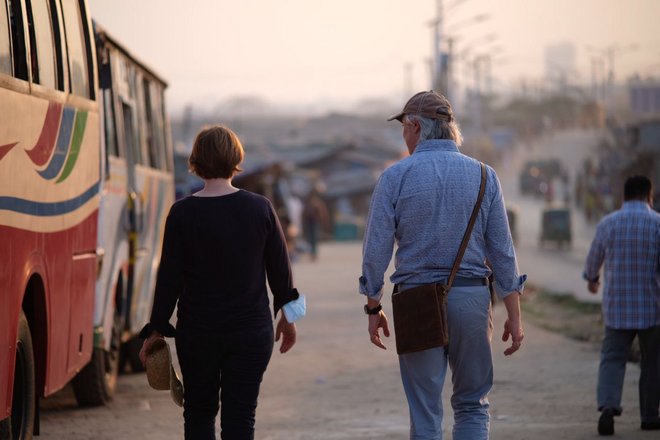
[359,139,527,300]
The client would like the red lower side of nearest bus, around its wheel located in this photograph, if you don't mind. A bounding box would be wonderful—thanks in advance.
[0,213,98,415]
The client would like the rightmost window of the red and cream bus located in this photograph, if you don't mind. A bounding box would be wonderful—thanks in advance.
[62,1,90,98]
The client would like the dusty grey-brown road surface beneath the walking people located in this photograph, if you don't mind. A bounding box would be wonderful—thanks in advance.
[40,243,660,440]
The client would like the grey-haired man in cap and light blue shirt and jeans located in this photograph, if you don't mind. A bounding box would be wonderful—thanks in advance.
[360,91,526,440]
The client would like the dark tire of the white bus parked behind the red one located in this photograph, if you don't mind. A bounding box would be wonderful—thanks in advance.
[73,316,121,407]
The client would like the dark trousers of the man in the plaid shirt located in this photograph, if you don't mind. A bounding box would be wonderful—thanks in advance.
[598,326,660,422]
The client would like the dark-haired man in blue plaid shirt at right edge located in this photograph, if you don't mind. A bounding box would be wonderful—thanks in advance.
[584,176,660,435]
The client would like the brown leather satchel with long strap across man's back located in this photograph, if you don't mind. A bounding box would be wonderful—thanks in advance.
[392,163,486,354]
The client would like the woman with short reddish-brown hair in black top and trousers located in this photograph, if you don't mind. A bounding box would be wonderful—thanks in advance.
[140,126,299,440]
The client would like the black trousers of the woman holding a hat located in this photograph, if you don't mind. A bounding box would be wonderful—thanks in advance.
[176,326,274,440]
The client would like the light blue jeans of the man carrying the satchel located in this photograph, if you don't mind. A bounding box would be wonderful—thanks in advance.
[399,284,493,440]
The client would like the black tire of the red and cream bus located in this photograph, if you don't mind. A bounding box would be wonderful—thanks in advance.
[7,311,36,440]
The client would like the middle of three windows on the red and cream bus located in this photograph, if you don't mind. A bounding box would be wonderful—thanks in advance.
[27,0,57,89]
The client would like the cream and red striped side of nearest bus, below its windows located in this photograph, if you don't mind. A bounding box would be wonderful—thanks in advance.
[0,88,100,402]
